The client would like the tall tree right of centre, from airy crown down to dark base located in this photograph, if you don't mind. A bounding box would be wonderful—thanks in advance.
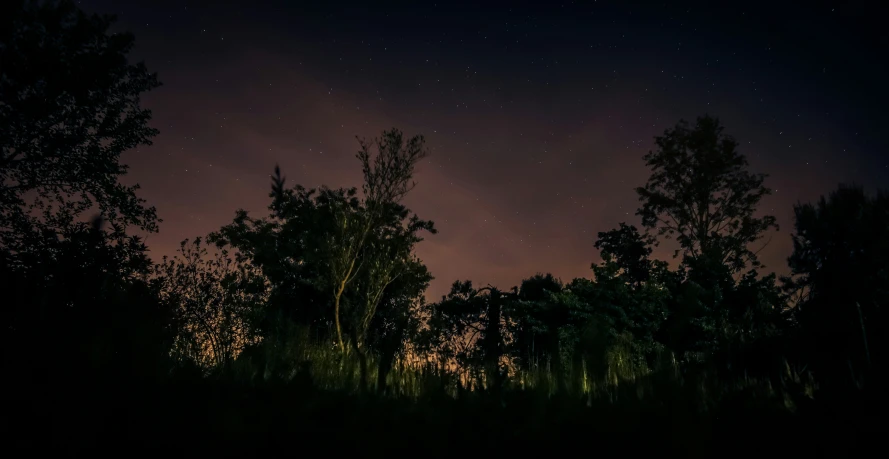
[634,115,781,366]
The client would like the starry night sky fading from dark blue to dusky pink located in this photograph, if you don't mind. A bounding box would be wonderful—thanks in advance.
[79,0,889,299]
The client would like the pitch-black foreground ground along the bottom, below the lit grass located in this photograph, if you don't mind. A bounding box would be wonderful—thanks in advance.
[4,382,889,457]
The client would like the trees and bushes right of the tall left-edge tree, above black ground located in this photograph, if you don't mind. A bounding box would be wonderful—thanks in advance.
[135,117,889,397]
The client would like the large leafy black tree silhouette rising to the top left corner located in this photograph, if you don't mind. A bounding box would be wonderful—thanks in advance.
[0,0,160,263]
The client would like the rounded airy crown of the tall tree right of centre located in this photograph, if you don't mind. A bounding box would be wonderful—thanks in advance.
[636,116,778,273]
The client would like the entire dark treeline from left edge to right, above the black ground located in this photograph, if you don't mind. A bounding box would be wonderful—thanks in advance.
[0,1,889,452]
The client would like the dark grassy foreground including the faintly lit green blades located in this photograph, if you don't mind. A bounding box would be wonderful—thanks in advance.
[10,345,882,457]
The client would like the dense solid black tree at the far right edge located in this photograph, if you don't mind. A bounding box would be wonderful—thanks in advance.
[783,185,889,390]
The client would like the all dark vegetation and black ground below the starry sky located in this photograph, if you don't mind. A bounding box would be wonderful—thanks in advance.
[0,1,889,457]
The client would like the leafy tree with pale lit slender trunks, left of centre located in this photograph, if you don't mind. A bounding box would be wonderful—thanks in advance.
[209,129,436,387]
